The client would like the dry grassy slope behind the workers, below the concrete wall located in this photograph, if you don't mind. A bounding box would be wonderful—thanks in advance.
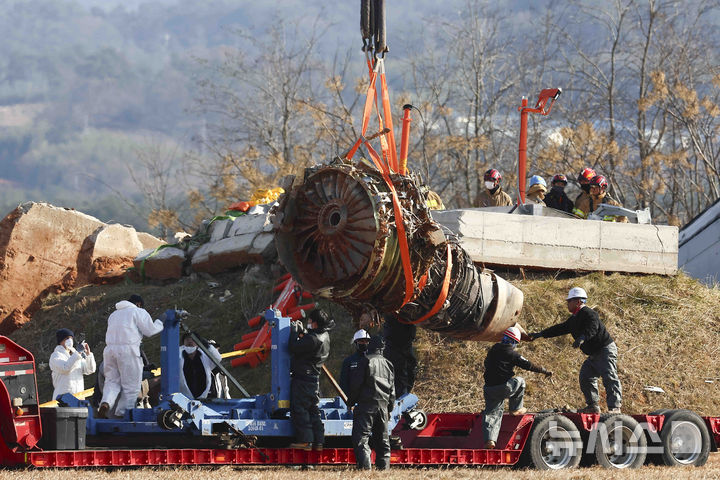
[11,267,720,415]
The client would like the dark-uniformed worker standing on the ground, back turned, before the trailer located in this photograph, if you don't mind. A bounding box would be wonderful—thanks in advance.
[348,335,395,470]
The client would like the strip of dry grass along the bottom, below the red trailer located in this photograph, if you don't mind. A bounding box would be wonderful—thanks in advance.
[0,454,720,480]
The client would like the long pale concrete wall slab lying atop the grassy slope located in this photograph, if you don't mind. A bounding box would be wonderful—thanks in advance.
[433,209,678,275]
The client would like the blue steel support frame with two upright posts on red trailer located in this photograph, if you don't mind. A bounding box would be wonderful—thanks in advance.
[71,310,418,437]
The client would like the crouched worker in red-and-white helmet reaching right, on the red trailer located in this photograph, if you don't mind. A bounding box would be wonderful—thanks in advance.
[482,327,552,449]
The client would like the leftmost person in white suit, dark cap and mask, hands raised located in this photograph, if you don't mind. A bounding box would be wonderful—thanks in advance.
[49,328,96,400]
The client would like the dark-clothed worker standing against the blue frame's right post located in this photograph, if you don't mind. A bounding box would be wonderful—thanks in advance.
[288,309,335,451]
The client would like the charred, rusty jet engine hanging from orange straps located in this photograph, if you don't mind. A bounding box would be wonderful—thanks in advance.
[273,158,523,341]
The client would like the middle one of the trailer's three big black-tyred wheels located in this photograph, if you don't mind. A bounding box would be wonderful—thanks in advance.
[591,415,647,468]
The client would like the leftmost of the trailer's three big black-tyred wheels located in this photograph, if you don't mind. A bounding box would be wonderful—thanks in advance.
[526,415,582,470]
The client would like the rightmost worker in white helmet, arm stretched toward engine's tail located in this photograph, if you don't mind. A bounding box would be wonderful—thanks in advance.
[530,287,622,413]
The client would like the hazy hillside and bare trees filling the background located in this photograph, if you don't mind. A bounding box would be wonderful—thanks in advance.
[0,0,720,235]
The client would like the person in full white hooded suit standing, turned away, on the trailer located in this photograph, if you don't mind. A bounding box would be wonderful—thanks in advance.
[98,295,164,418]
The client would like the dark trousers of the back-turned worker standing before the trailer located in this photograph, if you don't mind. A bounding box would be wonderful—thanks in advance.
[352,404,390,470]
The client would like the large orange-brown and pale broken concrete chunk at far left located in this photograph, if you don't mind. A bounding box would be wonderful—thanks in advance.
[0,202,162,334]
